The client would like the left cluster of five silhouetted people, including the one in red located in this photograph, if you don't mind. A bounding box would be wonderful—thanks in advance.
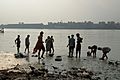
[15,31,54,59]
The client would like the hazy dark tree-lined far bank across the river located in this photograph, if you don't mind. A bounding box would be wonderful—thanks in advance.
[0,21,120,30]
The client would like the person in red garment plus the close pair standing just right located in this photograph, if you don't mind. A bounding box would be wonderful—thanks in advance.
[33,31,54,59]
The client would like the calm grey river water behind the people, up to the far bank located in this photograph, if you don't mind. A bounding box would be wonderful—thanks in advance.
[0,29,120,60]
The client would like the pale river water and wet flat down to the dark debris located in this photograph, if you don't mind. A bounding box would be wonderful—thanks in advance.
[0,29,120,80]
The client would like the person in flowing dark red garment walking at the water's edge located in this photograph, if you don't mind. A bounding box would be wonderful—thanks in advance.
[33,31,45,59]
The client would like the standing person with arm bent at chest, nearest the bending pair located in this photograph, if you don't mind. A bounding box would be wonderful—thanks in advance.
[76,33,83,58]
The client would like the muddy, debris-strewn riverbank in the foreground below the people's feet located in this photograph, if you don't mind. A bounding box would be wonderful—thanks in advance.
[0,52,120,80]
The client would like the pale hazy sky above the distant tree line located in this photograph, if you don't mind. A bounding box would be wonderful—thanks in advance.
[0,0,120,24]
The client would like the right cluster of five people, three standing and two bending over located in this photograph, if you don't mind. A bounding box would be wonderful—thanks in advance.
[67,33,111,60]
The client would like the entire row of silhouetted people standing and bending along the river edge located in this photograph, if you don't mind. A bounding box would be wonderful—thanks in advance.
[15,31,111,60]
